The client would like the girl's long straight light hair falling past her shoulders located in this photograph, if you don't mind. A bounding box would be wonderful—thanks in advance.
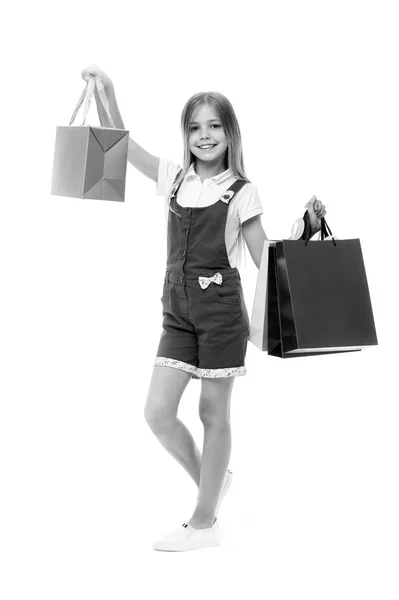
[173,91,251,264]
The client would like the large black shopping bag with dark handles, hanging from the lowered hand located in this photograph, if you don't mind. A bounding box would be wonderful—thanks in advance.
[267,218,378,358]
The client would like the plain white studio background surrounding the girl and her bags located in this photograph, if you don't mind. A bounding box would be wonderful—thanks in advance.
[0,0,399,600]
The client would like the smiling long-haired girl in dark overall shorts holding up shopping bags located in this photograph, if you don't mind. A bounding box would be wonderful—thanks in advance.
[82,65,326,551]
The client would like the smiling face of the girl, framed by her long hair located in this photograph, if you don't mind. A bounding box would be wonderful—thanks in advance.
[188,104,228,163]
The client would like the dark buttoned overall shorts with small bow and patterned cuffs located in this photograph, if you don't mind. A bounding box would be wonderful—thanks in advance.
[154,173,250,379]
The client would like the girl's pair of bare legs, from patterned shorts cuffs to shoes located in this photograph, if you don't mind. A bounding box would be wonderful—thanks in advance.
[145,367,235,527]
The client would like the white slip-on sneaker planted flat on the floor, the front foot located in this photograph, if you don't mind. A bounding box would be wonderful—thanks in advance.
[152,523,220,552]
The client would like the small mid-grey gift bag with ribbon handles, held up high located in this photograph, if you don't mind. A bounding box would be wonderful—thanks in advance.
[50,76,129,202]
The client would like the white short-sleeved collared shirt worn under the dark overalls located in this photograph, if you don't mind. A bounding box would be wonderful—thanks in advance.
[156,157,263,269]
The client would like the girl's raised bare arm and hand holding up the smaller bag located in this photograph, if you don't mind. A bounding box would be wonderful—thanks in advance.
[82,65,159,181]
